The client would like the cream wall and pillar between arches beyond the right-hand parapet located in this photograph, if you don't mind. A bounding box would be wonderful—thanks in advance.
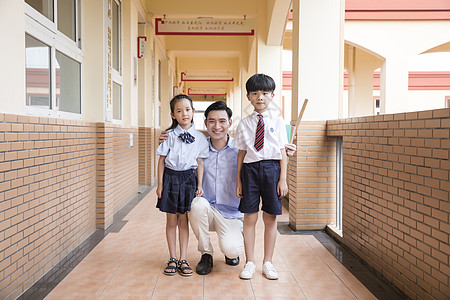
[344,20,450,113]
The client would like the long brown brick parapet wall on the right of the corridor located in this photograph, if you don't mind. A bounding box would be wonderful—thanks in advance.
[327,109,450,299]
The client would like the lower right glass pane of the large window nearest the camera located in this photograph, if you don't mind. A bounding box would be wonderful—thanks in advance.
[55,51,81,114]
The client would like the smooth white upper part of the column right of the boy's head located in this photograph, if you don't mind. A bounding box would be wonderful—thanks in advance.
[292,0,344,120]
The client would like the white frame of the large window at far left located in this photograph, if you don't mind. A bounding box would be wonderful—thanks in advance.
[24,0,83,120]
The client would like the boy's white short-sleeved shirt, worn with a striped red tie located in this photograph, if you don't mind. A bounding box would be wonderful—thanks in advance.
[234,110,288,163]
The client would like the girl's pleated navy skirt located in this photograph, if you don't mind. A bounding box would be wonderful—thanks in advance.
[156,168,197,214]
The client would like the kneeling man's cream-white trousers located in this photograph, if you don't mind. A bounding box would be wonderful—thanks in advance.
[189,197,244,258]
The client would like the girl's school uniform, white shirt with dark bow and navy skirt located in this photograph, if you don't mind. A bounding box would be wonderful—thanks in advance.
[156,125,209,214]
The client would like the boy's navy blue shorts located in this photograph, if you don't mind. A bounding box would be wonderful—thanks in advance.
[239,160,282,215]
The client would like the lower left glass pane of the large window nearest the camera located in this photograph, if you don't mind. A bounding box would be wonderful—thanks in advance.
[25,34,51,108]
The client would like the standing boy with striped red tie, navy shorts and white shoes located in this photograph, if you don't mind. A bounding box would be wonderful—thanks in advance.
[234,74,288,279]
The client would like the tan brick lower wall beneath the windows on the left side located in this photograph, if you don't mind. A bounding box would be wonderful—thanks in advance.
[0,114,142,299]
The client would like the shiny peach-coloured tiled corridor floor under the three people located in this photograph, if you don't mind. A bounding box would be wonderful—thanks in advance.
[23,191,404,300]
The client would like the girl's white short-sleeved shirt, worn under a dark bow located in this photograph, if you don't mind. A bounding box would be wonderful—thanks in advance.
[156,125,209,171]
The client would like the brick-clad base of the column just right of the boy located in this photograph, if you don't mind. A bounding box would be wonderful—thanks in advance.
[288,121,336,230]
